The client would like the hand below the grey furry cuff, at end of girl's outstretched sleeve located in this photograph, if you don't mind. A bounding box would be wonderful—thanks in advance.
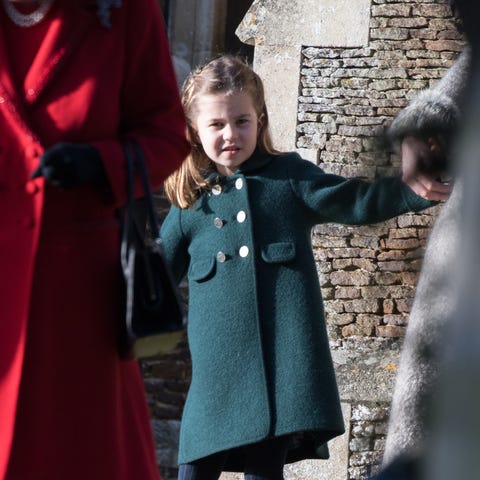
[401,137,452,201]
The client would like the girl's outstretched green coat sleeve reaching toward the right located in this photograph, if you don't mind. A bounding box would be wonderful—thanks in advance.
[289,155,436,225]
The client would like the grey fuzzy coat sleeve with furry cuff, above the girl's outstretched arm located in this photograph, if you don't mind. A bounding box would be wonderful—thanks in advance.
[388,47,471,144]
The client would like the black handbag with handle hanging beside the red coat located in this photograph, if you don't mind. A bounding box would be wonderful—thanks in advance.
[120,140,185,359]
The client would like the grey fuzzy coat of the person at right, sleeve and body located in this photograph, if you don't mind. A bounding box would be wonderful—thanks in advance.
[383,49,471,466]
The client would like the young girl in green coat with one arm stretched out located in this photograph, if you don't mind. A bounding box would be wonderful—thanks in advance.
[162,56,446,480]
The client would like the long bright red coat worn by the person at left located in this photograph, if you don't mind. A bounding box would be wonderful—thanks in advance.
[0,0,188,480]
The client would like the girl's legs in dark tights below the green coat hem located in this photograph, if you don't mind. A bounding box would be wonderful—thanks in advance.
[178,437,290,480]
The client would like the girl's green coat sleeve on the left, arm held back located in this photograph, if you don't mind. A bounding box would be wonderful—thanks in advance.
[160,207,190,283]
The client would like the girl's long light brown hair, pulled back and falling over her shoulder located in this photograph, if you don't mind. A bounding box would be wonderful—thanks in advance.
[165,55,279,208]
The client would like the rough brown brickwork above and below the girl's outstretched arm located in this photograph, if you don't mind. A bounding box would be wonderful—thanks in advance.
[297,0,463,345]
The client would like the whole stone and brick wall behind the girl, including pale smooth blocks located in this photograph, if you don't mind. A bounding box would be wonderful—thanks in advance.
[142,0,463,480]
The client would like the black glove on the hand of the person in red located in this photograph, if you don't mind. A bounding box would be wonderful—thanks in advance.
[31,143,108,189]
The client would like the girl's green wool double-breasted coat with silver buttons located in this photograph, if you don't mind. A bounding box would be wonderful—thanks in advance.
[161,152,432,463]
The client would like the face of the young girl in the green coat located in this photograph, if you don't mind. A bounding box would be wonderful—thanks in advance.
[195,93,262,175]
